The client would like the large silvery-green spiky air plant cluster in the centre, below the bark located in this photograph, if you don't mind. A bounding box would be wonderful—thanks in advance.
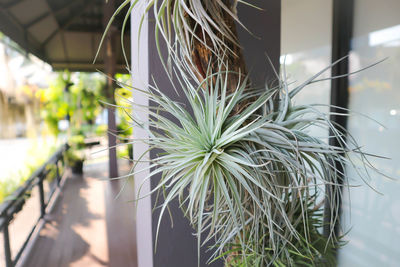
[114,55,382,266]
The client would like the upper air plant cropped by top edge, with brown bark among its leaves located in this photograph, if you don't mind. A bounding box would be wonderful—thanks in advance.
[94,0,248,87]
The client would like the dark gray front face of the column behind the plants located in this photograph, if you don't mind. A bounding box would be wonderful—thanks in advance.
[149,0,281,267]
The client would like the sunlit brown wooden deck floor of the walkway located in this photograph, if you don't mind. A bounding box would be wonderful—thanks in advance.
[24,161,136,267]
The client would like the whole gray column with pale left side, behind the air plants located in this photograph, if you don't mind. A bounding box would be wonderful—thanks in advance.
[132,0,281,267]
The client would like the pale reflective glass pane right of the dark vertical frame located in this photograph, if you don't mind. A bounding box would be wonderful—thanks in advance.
[339,0,400,267]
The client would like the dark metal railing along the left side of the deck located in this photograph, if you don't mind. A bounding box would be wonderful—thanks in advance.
[0,144,69,267]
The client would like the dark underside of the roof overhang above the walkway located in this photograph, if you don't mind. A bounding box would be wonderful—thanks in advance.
[0,0,130,73]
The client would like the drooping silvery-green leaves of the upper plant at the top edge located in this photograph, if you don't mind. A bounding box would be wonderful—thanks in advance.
[95,0,247,72]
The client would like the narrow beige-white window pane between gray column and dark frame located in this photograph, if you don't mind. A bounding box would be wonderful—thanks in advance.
[281,0,332,137]
